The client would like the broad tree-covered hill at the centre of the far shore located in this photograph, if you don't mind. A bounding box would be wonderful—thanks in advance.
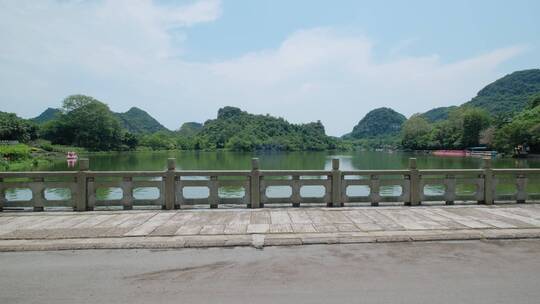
[197,107,335,150]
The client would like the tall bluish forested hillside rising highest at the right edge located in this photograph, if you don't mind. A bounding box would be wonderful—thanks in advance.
[463,69,540,115]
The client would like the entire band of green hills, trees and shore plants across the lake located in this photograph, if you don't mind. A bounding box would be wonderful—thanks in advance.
[0,69,540,170]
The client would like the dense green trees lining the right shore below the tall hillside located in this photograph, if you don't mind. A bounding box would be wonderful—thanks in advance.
[400,101,540,152]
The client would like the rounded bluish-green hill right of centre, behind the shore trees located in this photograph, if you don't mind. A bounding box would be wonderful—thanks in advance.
[343,108,407,139]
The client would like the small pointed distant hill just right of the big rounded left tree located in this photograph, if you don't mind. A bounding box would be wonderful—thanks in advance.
[114,107,167,134]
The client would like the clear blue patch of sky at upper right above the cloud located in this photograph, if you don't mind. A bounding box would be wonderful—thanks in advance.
[182,0,540,65]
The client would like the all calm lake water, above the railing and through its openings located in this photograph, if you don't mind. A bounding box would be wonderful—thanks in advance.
[6,151,540,200]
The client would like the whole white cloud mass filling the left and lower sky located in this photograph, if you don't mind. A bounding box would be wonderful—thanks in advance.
[0,0,524,135]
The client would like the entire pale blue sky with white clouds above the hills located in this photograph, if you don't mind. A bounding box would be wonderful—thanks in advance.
[0,0,540,135]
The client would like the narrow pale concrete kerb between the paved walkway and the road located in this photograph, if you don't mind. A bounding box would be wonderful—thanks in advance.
[0,229,540,252]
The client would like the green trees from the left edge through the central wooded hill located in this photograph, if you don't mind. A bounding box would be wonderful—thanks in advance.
[0,95,338,151]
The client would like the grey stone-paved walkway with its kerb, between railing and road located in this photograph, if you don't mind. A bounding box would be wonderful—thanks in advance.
[0,204,540,251]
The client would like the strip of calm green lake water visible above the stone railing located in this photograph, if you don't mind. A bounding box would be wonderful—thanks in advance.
[45,151,540,171]
